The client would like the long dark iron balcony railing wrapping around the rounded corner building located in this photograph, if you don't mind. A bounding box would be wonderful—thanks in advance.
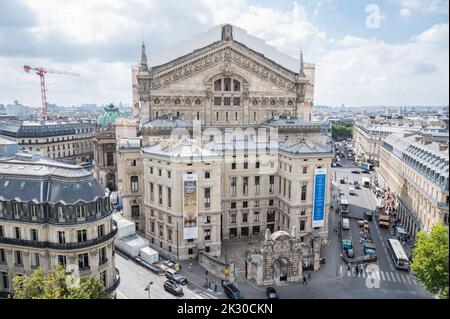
[0,228,117,250]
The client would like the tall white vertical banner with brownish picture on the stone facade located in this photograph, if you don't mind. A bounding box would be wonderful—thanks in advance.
[183,174,198,239]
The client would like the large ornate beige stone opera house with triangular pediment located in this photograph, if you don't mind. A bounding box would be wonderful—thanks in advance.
[125,25,332,268]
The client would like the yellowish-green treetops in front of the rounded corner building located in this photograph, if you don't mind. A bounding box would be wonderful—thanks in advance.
[12,265,111,299]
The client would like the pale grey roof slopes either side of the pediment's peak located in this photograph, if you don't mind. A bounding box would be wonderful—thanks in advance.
[149,25,300,73]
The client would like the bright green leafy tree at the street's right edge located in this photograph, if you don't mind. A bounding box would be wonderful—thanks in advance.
[411,222,449,299]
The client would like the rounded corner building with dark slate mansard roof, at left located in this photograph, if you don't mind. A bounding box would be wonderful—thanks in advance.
[0,153,119,296]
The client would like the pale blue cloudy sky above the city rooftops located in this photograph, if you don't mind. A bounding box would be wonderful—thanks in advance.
[0,0,449,106]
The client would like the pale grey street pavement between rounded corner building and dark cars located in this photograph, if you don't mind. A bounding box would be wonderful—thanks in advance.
[115,253,217,299]
